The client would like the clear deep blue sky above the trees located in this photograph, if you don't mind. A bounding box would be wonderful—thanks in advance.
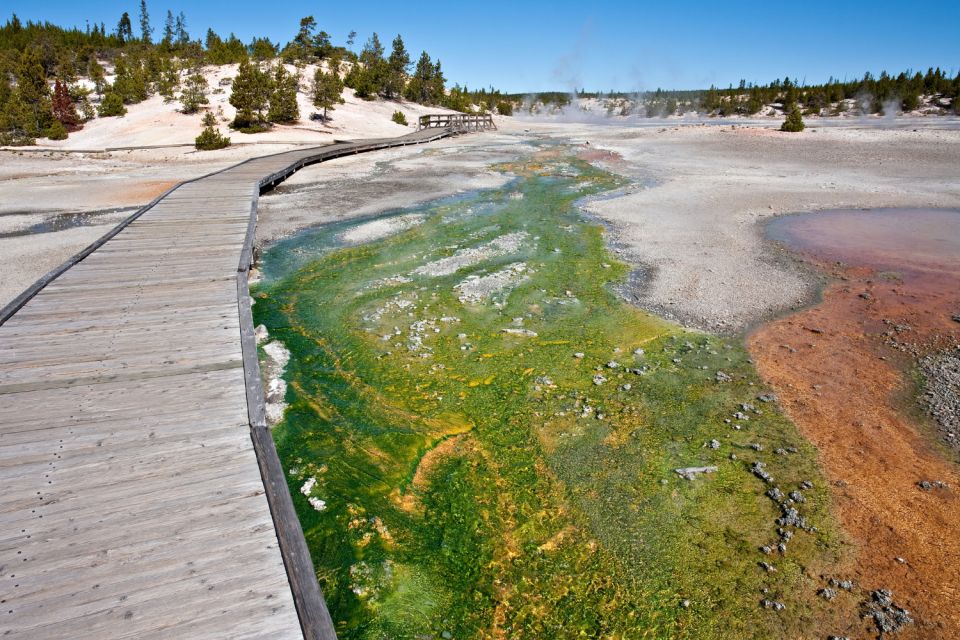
[0,0,960,92]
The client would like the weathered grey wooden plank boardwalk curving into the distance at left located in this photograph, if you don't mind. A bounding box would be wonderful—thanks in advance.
[0,129,458,640]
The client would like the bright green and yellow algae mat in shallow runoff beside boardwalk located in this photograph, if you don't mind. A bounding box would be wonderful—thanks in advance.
[253,146,840,639]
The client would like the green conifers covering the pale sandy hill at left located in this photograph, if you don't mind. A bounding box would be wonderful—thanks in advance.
[0,8,511,144]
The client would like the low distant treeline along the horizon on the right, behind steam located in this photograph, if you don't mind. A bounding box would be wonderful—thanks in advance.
[504,67,960,116]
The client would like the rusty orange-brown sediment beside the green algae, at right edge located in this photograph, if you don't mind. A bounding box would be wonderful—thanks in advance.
[748,209,960,639]
